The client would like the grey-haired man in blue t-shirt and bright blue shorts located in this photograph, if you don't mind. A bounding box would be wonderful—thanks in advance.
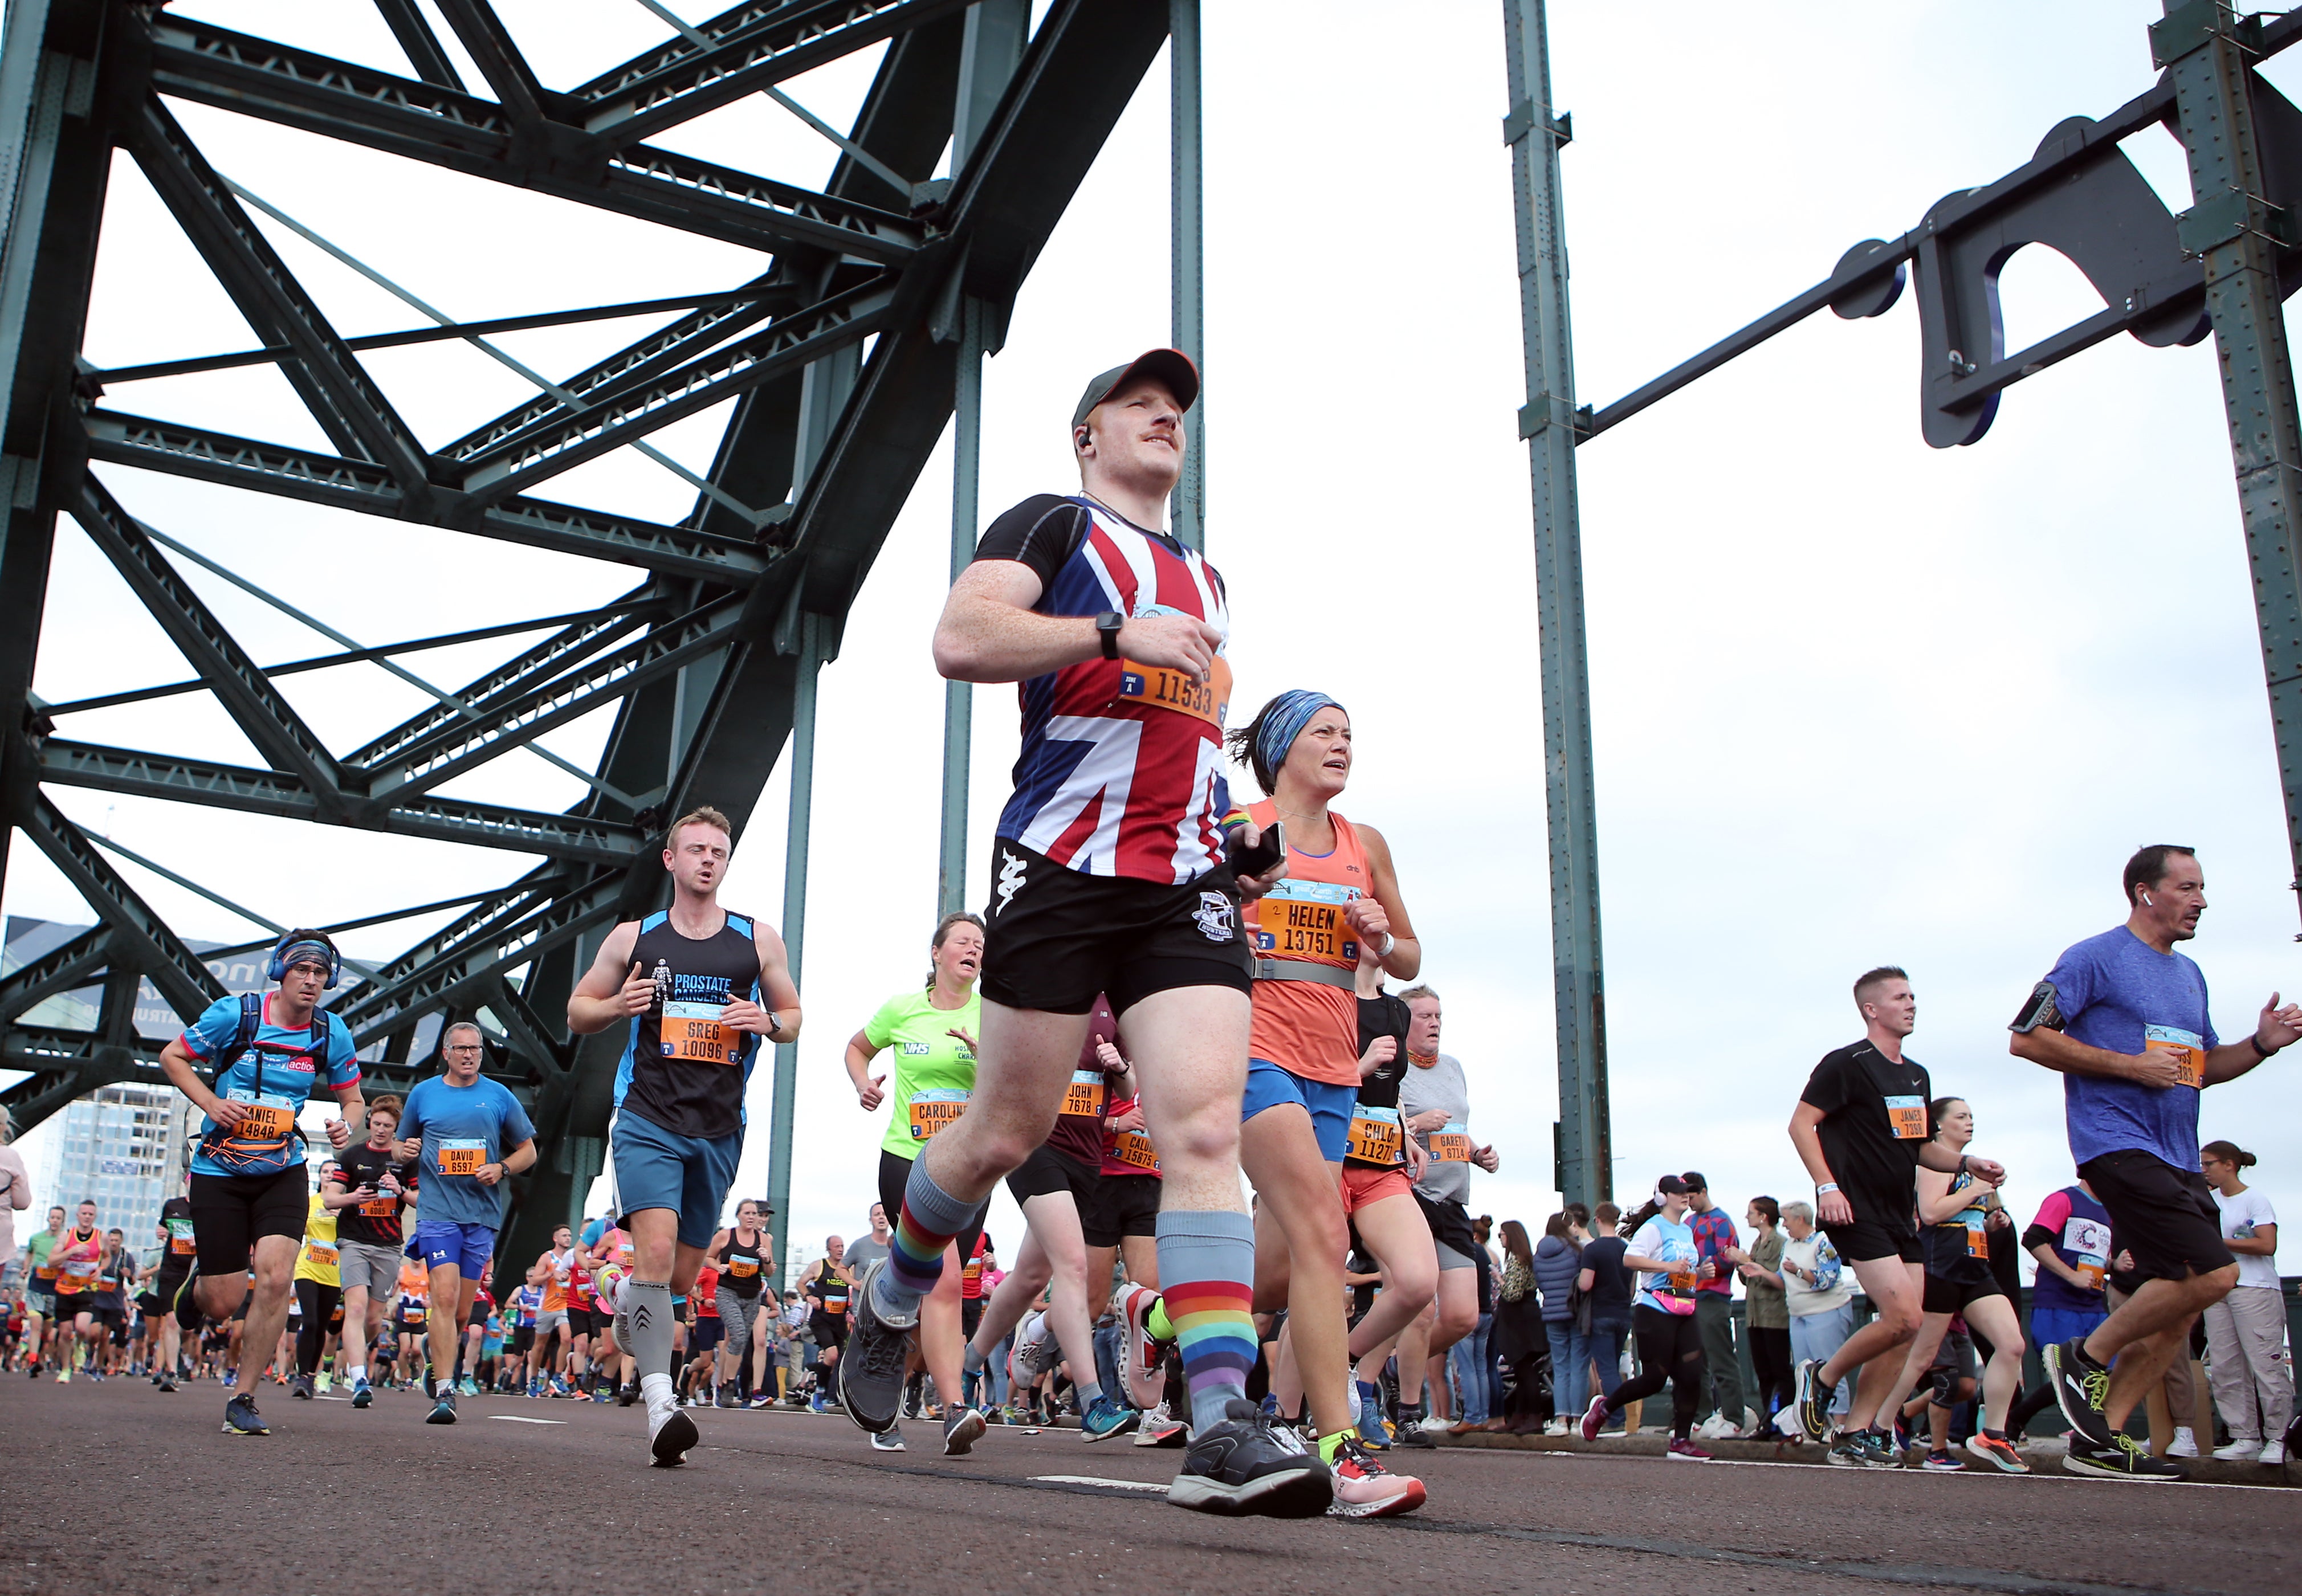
[401,1021,536,1423]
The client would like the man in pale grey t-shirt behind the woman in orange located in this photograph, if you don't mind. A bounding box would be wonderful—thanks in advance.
[1400,986,1498,1446]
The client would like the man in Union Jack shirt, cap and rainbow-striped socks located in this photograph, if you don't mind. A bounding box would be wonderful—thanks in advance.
[838,350,1333,1518]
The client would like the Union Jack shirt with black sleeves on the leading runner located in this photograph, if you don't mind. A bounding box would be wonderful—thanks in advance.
[976,493,1232,887]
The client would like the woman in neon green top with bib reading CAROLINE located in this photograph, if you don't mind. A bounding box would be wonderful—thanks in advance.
[847,912,983,1455]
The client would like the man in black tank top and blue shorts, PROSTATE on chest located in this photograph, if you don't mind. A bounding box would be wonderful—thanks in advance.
[569,809,799,1467]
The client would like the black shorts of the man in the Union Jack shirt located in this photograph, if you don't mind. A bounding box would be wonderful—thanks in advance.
[980,838,1254,1009]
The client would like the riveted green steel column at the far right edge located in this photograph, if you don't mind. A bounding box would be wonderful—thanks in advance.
[2150,0,2302,916]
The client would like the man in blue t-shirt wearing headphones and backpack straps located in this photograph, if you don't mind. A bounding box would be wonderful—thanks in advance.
[159,930,366,1435]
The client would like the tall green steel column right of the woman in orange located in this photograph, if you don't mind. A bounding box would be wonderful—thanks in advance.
[1503,0,1614,1202]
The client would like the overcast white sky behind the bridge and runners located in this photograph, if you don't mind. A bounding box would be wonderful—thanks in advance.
[5,0,2302,1267]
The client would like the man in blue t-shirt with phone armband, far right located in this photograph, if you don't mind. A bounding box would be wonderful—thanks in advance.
[2012,843,2302,1479]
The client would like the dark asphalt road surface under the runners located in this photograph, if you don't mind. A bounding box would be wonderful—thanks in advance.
[0,1375,2302,1596]
